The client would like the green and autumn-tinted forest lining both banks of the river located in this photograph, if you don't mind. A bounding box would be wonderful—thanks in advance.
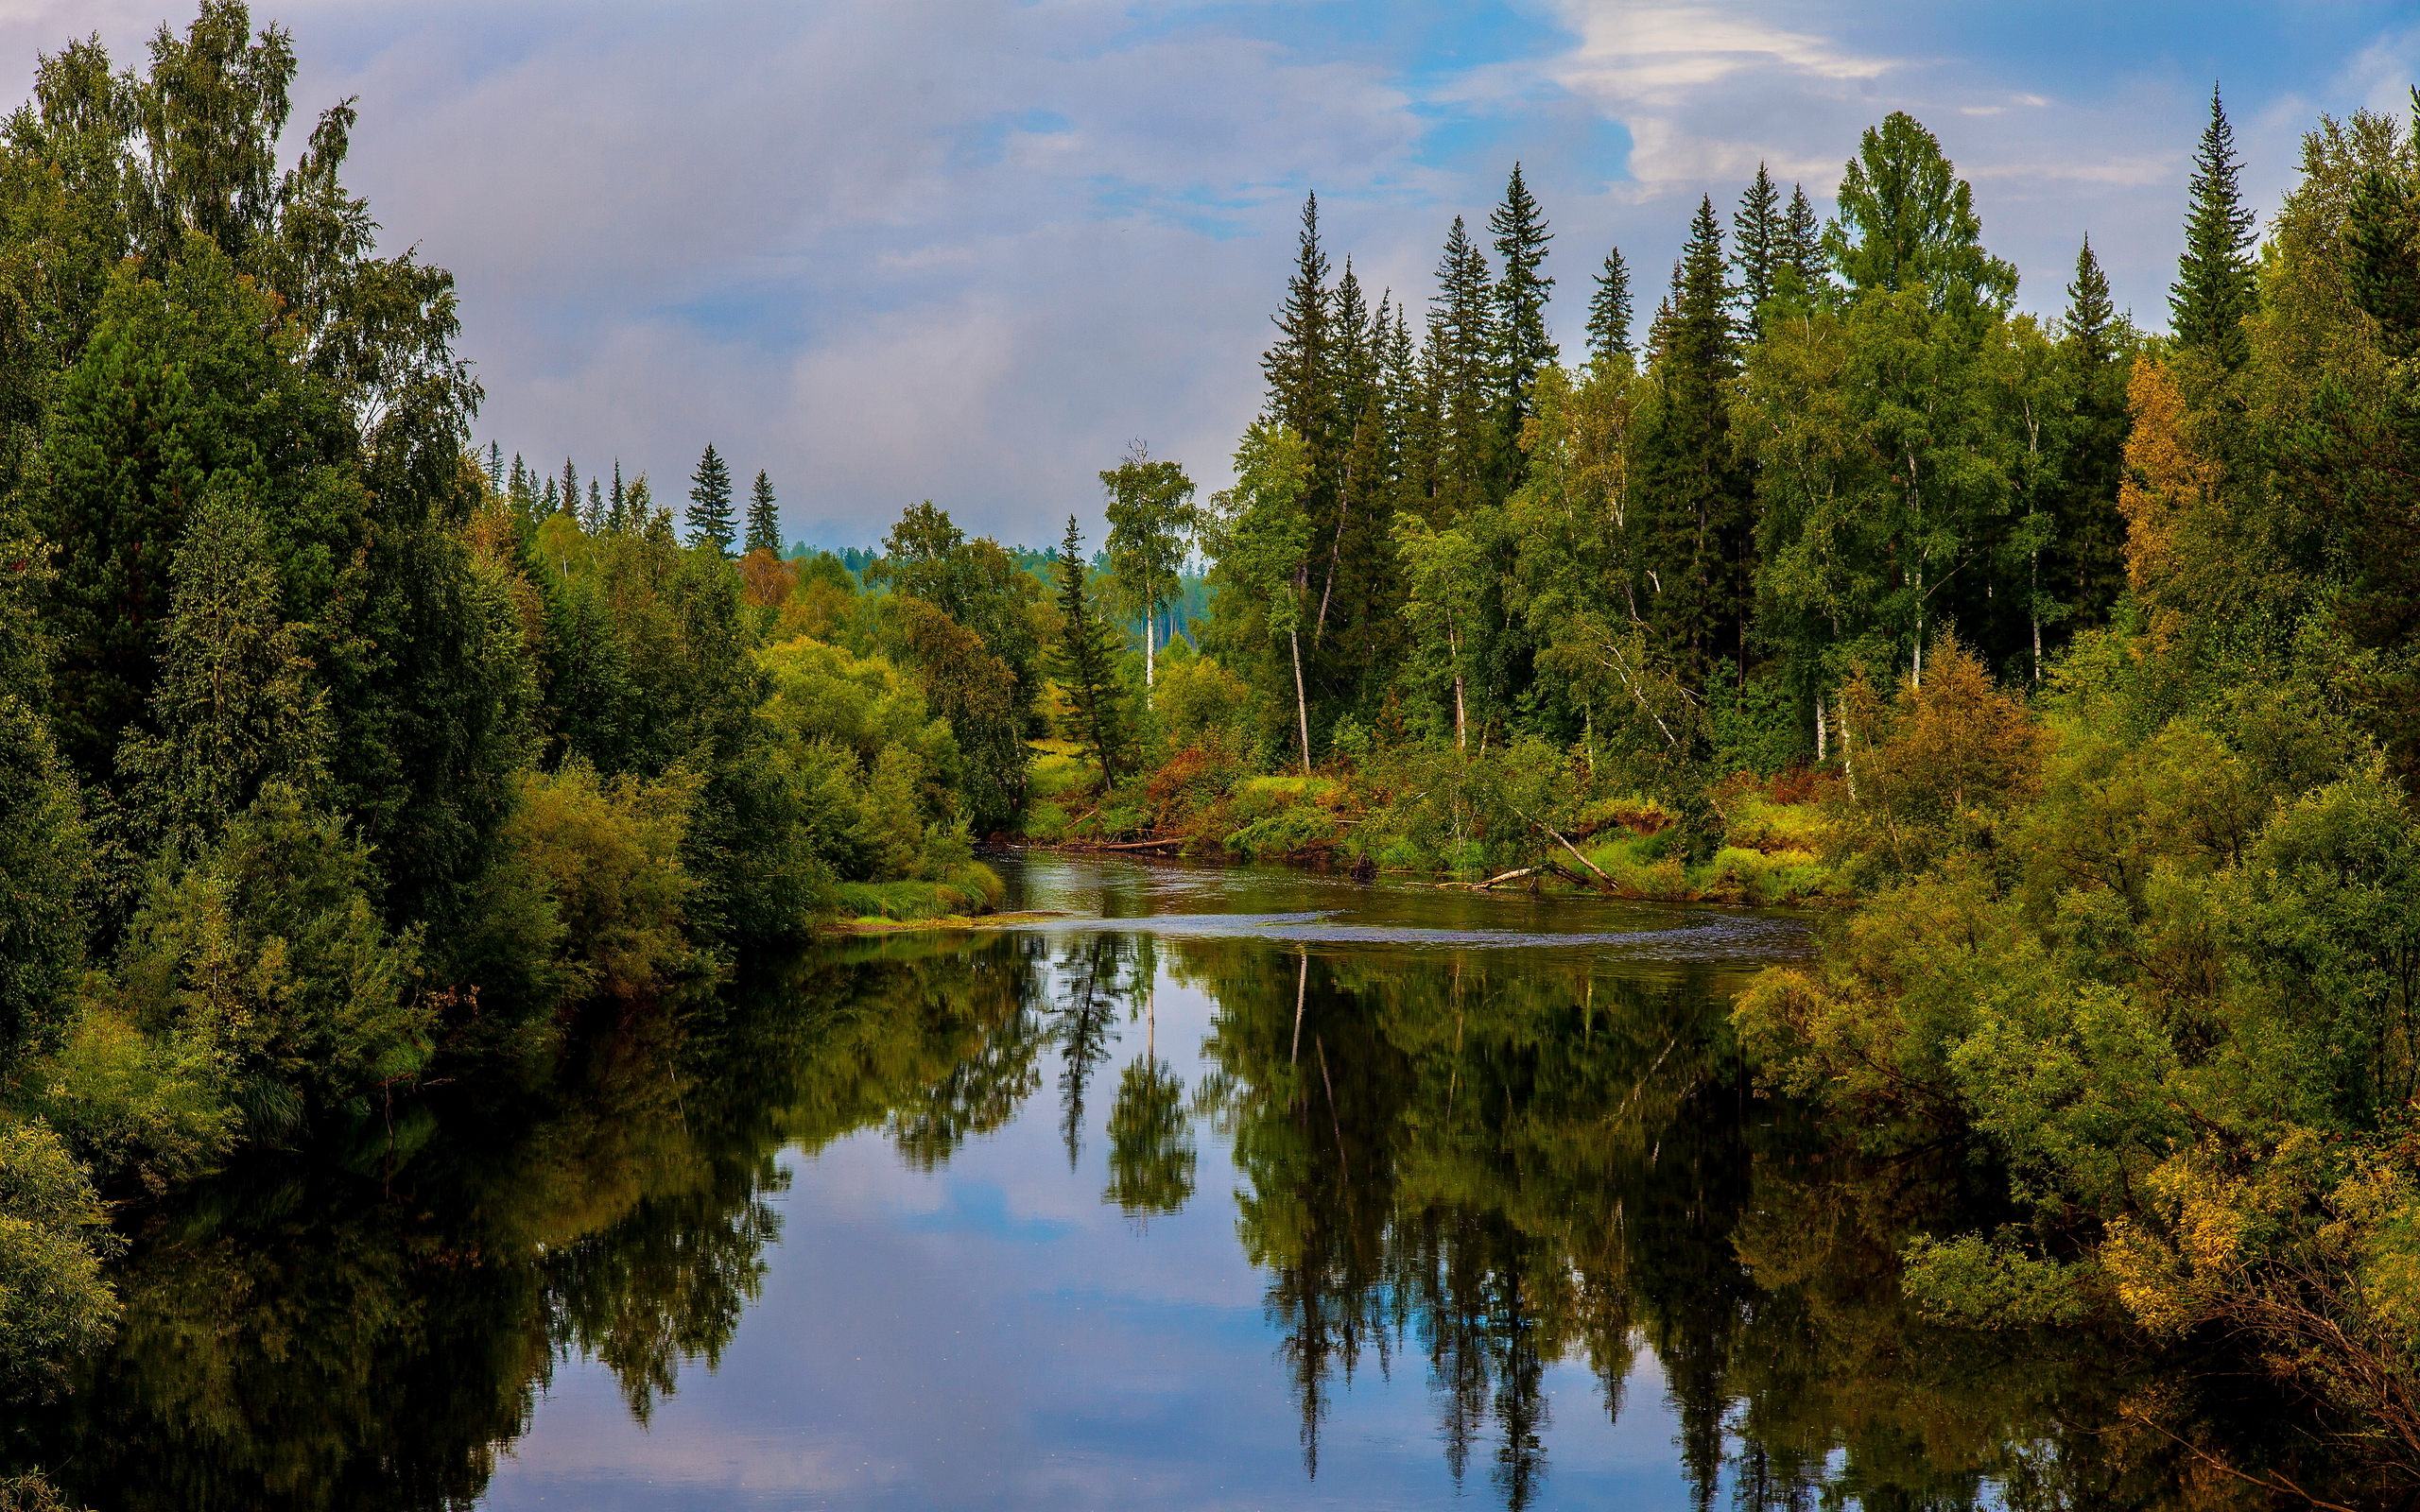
[0,0,2420,1495]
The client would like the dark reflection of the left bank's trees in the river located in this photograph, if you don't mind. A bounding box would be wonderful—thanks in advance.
[0,938,1046,1512]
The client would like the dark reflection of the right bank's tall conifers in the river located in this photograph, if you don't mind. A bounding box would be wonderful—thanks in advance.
[1179,941,2311,1512]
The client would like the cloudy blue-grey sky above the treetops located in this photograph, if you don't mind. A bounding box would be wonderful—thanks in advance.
[0,0,2420,547]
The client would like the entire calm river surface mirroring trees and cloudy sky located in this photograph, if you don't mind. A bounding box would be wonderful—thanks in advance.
[8,859,2304,1512]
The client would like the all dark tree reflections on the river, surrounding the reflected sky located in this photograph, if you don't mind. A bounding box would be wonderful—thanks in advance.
[8,866,2325,1509]
